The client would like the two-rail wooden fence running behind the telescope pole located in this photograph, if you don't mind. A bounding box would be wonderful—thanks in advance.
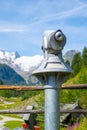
[0,84,87,114]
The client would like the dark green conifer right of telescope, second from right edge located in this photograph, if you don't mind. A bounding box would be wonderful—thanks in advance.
[71,52,82,76]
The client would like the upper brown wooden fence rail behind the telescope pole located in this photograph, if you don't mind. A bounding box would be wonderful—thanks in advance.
[0,84,87,91]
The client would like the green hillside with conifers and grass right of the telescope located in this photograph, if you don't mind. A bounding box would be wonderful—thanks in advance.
[60,47,87,104]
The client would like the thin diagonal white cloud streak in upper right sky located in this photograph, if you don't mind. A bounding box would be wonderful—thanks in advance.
[32,4,87,24]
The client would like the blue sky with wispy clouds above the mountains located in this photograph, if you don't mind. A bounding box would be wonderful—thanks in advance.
[0,0,87,56]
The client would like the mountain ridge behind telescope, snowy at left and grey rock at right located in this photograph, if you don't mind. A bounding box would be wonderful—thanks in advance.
[0,50,77,83]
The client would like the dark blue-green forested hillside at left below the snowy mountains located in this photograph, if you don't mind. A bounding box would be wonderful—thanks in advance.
[0,64,26,85]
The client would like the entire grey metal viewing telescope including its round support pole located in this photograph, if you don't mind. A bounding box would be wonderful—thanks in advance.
[33,30,72,130]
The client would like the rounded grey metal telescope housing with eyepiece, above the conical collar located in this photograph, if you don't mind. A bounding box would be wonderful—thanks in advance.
[42,29,66,55]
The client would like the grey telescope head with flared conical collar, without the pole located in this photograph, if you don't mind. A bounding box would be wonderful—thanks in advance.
[33,29,72,84]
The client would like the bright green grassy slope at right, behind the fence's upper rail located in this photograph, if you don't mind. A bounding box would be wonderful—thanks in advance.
[61,68,87,108]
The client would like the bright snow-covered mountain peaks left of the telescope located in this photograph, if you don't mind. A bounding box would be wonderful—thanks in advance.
[0,50,43,72]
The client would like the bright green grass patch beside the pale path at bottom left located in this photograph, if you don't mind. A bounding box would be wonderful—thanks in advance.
[4,121,23,130]
